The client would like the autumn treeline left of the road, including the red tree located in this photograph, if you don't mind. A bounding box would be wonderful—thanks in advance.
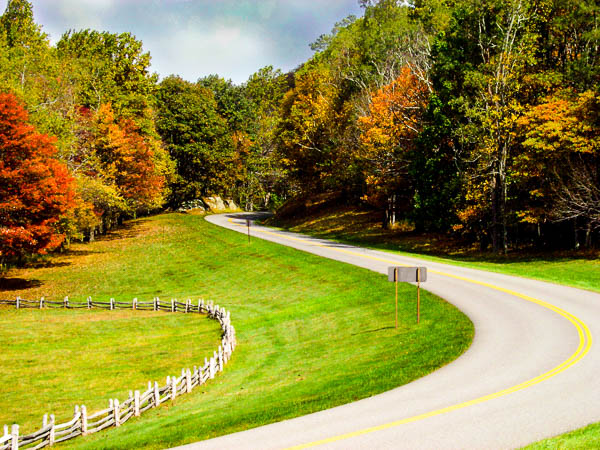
[0,0,287,269]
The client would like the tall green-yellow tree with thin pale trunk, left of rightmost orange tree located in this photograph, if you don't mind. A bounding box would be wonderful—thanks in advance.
[429,0,535,252]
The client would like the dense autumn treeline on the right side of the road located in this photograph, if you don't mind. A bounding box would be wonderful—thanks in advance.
[277,0,600,252]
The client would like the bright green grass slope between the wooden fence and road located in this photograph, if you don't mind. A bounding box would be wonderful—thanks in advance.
[2,214,473,448]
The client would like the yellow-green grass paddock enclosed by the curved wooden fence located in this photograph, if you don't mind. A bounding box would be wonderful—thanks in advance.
[0,308,221,434]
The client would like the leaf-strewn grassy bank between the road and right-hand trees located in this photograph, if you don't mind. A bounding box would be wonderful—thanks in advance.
[268,207,600,292]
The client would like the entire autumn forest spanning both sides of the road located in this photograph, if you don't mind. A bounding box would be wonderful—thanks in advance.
[0,0,600,268]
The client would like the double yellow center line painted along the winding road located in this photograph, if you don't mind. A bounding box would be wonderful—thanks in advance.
[228,219,592,450]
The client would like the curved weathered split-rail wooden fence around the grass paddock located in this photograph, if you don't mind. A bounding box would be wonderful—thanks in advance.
[0,297,236,450]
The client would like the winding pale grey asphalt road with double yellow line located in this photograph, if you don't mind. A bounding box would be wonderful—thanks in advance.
[176,214,600,449]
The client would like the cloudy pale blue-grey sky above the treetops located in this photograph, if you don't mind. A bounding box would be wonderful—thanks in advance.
[5,0,362,84]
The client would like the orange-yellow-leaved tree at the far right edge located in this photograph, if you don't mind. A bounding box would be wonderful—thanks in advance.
[514,89,600,247]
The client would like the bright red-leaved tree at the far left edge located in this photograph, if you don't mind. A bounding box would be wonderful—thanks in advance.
[0,93,75,262]
